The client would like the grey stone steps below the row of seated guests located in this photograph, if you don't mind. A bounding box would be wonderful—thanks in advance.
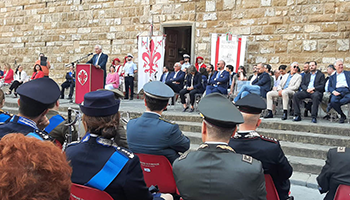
[4,101,350,188]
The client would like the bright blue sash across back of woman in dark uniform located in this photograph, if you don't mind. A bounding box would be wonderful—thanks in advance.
[82,134,129,191]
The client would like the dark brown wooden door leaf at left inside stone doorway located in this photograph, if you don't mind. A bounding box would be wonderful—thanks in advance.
[164,29,179,68]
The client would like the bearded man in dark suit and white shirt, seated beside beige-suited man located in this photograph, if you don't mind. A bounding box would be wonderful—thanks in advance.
[293,61,325,123]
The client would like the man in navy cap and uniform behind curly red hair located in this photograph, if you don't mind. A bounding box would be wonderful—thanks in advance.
[0,78,60,140]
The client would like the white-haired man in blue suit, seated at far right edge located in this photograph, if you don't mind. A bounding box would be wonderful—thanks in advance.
[327,60,350,123]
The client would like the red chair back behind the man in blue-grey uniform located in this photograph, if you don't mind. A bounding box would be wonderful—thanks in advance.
[136,153,177,194]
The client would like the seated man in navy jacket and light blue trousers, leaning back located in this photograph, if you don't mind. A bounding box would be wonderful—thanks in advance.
[233,63,271,102]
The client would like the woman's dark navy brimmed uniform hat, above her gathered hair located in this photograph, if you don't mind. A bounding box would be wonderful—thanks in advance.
[80,90,120,117]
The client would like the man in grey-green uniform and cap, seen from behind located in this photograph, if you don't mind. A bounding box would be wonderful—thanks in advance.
[173,93,266,200]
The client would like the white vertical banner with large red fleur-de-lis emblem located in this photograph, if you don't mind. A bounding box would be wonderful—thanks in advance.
[137,36,165,92]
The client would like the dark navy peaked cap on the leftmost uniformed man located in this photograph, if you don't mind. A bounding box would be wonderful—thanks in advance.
[17,77,60,105]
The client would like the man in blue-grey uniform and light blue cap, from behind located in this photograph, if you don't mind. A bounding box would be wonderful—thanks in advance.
[126,81,190,163]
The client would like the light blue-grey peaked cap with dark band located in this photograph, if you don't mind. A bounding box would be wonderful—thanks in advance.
[143,81,174,100]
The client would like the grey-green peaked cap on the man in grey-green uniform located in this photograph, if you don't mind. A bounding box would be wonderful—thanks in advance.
[198,93,244,128]
